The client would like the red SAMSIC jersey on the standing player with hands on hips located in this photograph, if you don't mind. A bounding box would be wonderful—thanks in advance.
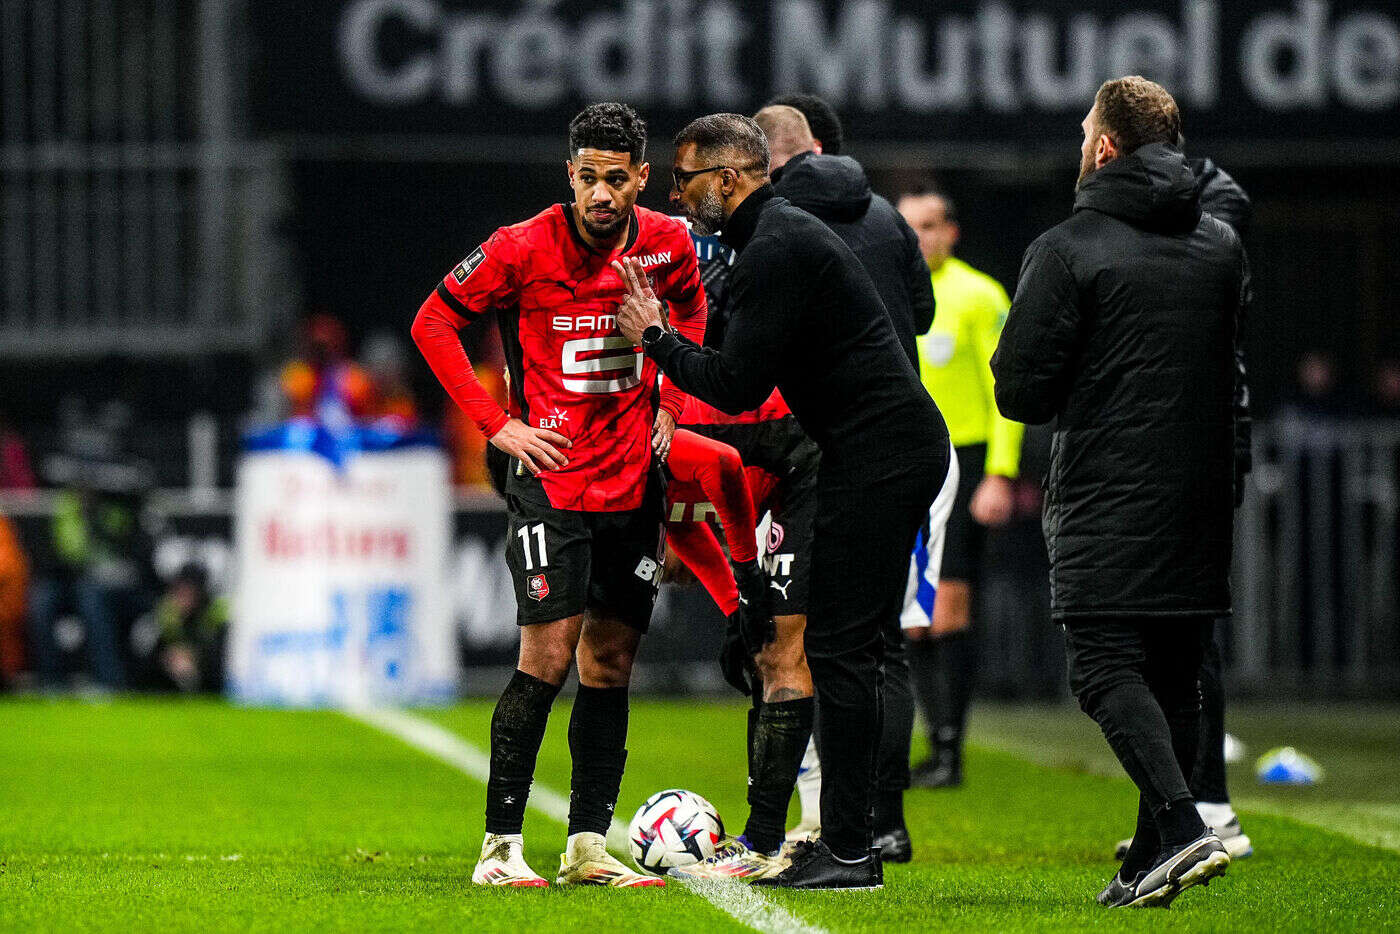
[413,204,706,513]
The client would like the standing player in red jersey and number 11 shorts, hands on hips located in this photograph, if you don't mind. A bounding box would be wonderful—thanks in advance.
[413,104,705,888]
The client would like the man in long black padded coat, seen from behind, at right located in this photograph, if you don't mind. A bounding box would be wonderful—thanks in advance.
[991,77,1249,905]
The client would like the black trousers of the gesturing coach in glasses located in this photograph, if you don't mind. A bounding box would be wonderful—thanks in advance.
[805,453,948,857]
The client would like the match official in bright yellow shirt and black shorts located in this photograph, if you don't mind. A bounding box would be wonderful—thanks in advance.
[899,190,1025,788]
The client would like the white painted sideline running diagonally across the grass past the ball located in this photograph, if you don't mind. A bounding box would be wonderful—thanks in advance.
[346,707,827,934]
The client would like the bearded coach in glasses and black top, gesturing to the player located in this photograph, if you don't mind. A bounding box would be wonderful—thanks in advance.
[617,113,949,888]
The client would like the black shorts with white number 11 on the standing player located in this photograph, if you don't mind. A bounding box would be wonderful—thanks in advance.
[505,478,666,633]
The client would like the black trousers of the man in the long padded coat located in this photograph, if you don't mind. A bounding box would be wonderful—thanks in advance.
[1064,616,1215,843]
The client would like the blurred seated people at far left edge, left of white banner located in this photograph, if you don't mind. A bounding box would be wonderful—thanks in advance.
[0,398,228,693]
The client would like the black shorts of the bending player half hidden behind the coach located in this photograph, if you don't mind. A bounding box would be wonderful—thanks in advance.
[685,416,822,616]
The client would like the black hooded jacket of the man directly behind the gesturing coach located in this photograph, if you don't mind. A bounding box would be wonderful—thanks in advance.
[773,153,934,371]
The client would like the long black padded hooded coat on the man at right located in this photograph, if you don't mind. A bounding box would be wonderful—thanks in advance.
[991,144,1249,619]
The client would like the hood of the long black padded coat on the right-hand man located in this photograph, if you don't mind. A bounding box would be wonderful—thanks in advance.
[1074,143,1201,232]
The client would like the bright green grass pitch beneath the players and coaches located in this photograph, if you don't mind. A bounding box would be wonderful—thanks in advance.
[0,700,1400,934]
